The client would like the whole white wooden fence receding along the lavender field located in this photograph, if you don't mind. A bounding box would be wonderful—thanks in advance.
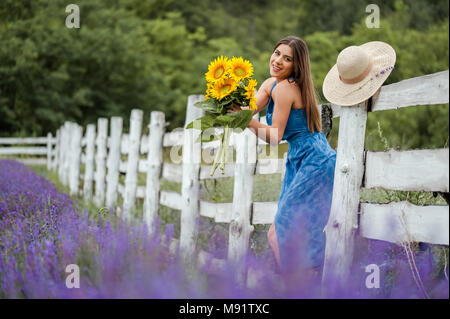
[5,70,449,290]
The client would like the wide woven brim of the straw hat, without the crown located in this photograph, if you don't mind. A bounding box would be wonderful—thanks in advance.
[322,41,396,106]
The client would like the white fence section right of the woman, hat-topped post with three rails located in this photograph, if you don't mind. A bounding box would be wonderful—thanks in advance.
[322,70,449,294]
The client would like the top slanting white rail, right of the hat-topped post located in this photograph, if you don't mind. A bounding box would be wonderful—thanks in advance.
[372,70,449,112]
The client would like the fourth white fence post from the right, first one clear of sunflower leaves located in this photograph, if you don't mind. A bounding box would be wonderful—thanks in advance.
[144,111,165,232]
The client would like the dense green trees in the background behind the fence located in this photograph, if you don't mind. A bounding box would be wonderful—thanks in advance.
[0,0,449,148]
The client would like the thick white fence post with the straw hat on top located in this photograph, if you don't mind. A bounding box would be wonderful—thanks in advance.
[322,101,367,296]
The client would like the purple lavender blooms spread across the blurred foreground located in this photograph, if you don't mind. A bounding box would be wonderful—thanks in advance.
[0,160,448,298]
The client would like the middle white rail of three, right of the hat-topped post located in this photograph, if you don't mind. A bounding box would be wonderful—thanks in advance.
[364,148,449,192]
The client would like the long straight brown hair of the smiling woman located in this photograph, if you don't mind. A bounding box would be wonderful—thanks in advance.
[273,36,322,133]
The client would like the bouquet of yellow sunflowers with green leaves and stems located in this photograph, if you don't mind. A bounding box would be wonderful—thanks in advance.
[186,56,257,176]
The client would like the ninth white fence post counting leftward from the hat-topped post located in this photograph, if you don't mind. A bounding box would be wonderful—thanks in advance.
[69,123,83,195]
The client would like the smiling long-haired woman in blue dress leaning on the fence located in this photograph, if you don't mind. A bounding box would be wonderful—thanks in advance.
[231,36,336,273]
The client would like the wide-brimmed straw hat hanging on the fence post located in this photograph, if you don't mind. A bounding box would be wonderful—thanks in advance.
[322,41,395,106]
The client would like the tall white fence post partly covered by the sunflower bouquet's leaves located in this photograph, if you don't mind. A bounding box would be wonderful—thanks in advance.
[180,95,204,258]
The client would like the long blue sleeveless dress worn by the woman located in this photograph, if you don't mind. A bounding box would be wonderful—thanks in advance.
[266,81,336,271]
